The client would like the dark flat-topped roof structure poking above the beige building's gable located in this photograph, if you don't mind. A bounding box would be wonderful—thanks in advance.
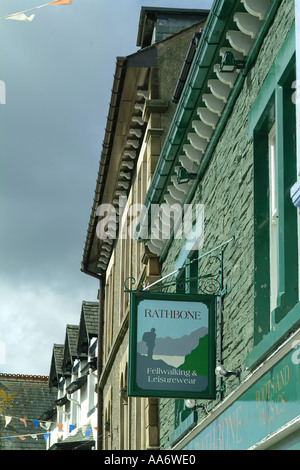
[136,7,209,48]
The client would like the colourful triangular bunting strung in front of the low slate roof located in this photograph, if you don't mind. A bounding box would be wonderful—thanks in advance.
[0,415,97,442]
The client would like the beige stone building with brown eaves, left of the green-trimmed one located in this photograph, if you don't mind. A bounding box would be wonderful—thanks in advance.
[82,7,208,450]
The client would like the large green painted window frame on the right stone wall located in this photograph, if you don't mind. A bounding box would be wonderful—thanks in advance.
[247,26,299,367]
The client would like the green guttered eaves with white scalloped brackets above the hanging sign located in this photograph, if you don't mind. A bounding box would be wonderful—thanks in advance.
[140,0,281,262]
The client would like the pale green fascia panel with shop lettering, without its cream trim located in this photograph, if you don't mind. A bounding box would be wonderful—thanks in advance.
[182,347,300,450]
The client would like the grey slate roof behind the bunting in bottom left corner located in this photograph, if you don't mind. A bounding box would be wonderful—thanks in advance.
[0,374,57,450]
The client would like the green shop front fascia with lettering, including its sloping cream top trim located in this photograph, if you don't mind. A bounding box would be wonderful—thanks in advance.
[170,333,300,450]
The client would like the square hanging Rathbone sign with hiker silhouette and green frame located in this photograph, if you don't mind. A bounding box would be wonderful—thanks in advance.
[128,291,216,399]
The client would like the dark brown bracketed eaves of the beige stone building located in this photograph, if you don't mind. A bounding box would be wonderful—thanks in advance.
[81,46,157,277]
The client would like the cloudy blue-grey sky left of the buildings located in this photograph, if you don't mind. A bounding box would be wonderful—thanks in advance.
[0,0,213,375]
